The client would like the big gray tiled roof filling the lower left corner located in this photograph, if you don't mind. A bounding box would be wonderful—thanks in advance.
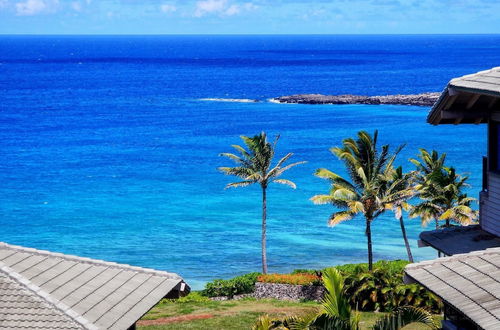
[0,243,189,329]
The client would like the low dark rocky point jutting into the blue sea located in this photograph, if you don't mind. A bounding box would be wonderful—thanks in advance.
[269,92,441,106]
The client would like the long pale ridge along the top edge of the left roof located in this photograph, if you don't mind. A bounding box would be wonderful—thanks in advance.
[0,242,181,279]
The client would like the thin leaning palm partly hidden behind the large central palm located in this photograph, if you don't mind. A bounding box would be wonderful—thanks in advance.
[387,166,415,263]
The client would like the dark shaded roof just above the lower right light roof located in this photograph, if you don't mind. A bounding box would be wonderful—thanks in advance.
[420,225,500,255]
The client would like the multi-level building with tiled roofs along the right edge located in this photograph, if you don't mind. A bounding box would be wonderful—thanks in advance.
[405,67,500,329]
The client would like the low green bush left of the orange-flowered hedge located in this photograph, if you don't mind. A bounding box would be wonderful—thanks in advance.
[201,273,260,297]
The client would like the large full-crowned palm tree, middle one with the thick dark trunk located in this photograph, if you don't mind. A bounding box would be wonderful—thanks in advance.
[311,131,411,271]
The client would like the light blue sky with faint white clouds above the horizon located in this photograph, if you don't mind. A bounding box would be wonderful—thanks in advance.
[0,0,500,34]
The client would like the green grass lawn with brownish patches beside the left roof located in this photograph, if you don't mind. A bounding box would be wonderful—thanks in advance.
[138,294,442,330]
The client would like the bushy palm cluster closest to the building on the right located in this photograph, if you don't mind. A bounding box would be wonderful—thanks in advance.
[410,149,478,229]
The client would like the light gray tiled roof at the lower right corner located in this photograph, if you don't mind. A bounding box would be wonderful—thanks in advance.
[405,248,500,329]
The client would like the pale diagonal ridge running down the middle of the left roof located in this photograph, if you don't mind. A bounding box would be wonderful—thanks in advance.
[0,261,98,330]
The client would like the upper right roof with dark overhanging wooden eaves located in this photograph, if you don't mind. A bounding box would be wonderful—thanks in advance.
[427,67,500,125]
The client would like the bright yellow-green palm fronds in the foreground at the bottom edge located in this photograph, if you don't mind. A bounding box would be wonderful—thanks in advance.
[252,268,437,330]
